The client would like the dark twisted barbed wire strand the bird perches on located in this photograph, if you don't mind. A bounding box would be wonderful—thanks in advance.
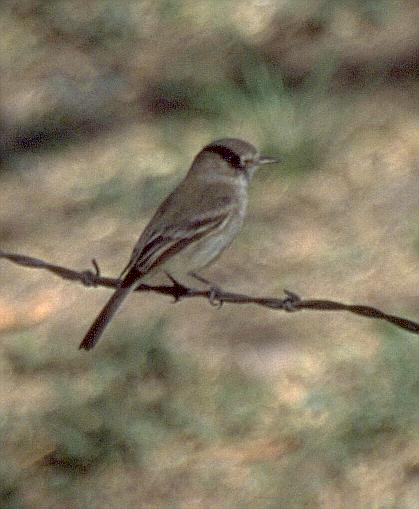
[0,251,419,334]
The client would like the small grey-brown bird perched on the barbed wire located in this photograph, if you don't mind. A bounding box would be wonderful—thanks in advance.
[79,138,279,350]
